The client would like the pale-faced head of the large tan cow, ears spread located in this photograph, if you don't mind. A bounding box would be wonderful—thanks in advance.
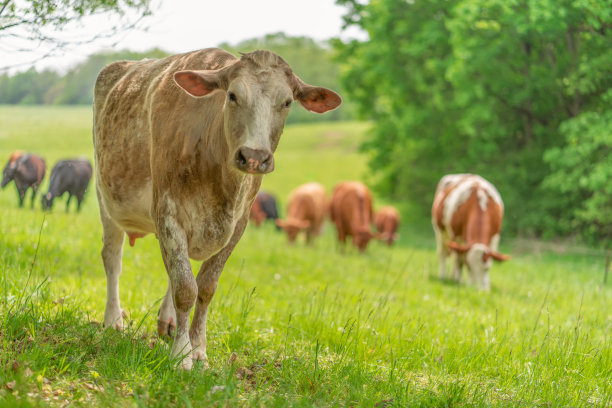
[174,50,342,174]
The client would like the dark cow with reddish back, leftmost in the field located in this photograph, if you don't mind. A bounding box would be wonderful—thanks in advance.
[2,150,46,208]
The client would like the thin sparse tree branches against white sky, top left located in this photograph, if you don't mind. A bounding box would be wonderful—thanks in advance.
[0,0,152,69]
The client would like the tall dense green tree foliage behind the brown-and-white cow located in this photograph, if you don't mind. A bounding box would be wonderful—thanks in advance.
[336,0,612,242]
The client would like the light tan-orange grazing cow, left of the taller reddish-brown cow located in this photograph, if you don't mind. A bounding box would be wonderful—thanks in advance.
[276,183,326,244]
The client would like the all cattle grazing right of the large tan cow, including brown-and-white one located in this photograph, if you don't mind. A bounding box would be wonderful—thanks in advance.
[249,174,509,290]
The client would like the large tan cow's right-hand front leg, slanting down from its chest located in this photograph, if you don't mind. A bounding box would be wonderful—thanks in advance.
[189,213,248,367]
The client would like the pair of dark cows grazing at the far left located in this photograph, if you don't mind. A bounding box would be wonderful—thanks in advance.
[2,150,92,212]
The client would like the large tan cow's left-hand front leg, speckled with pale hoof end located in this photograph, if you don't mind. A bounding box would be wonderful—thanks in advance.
[157,217,198,370]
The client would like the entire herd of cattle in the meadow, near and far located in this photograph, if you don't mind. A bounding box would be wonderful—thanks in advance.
[2,48,507,369]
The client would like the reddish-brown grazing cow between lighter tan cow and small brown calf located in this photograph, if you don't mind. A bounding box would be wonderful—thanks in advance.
[329,181,375,252]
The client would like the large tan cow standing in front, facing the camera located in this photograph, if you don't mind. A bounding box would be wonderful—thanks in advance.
[93,48,342,369]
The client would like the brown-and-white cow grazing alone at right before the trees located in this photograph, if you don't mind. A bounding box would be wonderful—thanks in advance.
[432,174,510,290]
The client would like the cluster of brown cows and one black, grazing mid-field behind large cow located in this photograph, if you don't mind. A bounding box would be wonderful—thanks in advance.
[249,181,400,252]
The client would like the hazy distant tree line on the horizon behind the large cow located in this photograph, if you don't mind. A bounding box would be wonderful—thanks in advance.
[0,33,354,123]
